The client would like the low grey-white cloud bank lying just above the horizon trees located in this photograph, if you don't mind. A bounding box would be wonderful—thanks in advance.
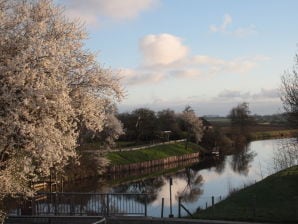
[119,88,283,116]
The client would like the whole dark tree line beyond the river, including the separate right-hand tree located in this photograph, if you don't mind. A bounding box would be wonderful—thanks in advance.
[116,103,254,151]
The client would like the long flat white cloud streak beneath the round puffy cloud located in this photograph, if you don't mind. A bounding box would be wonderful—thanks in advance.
[120,55,268,85]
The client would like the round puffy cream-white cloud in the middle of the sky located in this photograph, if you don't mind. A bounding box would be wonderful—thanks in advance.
[140,33,188,66]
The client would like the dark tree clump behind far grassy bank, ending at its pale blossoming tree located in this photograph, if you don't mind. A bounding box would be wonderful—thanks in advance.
[117,106,204,143]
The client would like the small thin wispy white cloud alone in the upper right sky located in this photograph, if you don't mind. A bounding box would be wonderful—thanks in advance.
[209,14,257,37]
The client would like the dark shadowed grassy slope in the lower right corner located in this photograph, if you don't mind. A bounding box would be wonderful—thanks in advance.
[194,166,298,223]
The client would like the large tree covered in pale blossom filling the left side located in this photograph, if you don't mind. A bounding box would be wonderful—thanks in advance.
[0,0,123,206]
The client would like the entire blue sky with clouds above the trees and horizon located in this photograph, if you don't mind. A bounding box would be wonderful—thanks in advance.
[55,0,298,116]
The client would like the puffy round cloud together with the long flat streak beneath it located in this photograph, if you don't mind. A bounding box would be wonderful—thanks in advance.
[120,33,269,85]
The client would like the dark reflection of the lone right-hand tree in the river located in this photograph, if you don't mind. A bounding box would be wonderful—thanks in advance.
[231,143,256,176]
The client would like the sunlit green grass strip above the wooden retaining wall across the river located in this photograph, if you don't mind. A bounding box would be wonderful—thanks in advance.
[107,142,202,165]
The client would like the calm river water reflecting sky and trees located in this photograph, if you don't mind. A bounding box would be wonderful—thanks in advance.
[60,139,287,217]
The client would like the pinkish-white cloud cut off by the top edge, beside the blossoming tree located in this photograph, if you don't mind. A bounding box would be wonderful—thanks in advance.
[58,0,159,25]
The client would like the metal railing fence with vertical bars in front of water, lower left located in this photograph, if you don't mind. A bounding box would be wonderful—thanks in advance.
[11,193,147,216]
